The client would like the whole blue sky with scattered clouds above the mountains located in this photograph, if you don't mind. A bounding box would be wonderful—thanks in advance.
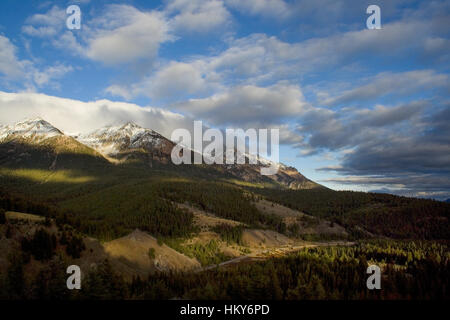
[0,0,450,199]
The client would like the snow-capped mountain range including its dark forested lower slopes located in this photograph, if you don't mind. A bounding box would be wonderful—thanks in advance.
[0,118,450,239]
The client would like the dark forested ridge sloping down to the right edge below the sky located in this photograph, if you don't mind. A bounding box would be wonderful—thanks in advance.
[248,188,450,240]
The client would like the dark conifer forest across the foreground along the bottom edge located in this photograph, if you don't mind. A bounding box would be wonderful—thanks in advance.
[0,240,450,300]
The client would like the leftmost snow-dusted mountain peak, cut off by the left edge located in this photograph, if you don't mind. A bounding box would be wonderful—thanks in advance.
[0,118,64,142]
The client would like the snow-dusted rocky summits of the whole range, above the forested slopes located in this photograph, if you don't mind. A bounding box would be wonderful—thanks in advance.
[0,118,317,189]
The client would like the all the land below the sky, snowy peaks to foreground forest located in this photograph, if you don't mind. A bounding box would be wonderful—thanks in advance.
[0,119,450,299]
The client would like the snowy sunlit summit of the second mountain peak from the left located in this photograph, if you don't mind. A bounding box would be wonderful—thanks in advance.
[77,122,168,155]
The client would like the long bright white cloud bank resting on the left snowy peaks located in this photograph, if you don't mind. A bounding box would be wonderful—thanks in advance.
[0,91,192,137]
